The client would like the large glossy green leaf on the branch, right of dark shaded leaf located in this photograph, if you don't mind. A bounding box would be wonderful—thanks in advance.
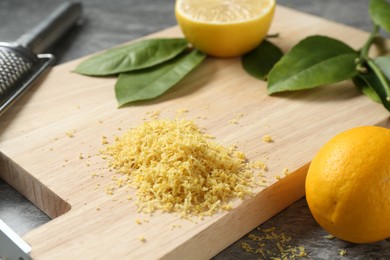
[268,36,358,95]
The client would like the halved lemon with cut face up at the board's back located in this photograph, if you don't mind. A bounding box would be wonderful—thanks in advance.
[175,0,275,57]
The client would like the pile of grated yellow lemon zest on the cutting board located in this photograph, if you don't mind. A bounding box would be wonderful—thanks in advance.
[101,119,253,217]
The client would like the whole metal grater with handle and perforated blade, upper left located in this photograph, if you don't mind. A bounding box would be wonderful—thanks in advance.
[0,2,81,115]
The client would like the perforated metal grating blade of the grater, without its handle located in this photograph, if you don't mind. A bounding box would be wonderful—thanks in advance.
[0,42,54,115]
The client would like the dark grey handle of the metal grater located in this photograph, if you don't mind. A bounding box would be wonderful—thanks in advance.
[16,2,82,54]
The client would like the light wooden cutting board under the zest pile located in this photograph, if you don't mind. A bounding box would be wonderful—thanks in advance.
[0,6,389,259]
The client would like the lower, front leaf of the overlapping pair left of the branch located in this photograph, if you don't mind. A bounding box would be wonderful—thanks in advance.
[115,50,206,107]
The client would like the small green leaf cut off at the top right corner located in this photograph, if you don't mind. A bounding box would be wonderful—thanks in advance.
[369,0,390,32]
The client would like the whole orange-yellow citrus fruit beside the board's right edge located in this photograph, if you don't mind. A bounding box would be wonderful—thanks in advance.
[306,126,390,243]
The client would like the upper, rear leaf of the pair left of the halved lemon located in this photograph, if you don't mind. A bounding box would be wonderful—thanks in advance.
[75,38,188,76]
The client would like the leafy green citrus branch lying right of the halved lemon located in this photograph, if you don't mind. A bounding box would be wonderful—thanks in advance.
[242,0,390,111]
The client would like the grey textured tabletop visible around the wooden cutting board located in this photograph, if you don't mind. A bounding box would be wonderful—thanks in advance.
[0,0,390,259]
